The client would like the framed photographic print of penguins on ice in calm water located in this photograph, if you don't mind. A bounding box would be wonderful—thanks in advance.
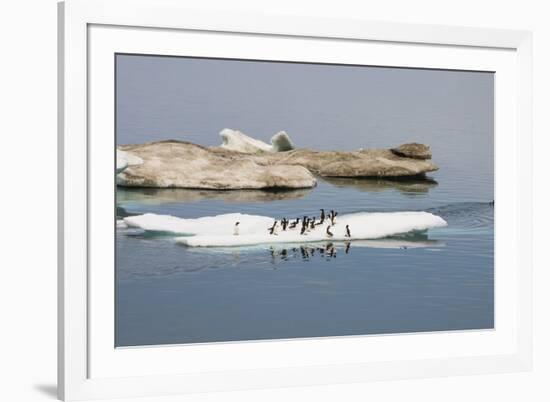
[113,54,494,347]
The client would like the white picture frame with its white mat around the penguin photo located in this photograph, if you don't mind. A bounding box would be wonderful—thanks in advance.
[58,0,532,400]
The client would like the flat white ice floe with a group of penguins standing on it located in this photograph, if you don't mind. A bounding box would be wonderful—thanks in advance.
[124,212,447,247]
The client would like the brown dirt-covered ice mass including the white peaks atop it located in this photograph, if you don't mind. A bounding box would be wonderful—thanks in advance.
[117,129,438,190]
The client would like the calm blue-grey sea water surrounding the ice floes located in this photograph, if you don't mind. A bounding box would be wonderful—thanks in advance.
[116,56,494,346]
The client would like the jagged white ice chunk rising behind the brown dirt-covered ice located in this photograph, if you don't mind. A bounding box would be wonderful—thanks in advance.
[220,128,294,153]
